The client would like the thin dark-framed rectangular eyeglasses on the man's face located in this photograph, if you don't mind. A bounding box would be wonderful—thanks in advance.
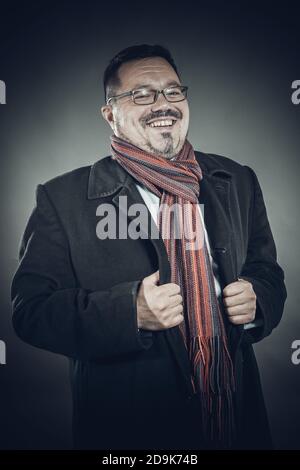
[106,85,188,105]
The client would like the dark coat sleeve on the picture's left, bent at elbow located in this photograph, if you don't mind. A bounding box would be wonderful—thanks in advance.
[11,184,152,360]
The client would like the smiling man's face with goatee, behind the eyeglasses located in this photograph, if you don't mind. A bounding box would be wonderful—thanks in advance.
[101,57,189,158]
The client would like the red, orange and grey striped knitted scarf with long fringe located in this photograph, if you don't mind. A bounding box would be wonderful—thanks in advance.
[111,135,234,448]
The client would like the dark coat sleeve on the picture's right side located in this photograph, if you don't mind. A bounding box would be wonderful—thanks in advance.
[239,165,287,343]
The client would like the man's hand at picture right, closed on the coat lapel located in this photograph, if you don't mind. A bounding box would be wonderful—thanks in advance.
[223,279,256,325]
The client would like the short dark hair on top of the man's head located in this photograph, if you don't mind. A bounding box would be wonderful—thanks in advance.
[103,44,180,102]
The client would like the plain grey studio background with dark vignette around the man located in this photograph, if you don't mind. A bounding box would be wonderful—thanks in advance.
[0,1,300,449]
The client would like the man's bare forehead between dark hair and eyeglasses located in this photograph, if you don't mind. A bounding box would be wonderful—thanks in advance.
[118,57,180,88]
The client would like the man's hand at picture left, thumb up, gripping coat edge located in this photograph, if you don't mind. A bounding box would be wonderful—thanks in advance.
[137,271,183,330]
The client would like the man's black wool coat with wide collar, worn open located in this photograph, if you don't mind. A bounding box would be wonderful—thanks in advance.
[11,152,286,449]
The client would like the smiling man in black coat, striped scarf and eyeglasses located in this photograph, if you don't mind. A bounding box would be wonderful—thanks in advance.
[12,45,286,449]
